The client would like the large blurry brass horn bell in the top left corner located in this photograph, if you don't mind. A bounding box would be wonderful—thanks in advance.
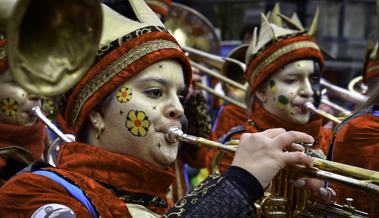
[0,0,102,96]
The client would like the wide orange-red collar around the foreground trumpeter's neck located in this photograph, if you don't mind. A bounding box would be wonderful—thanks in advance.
[57,142,175,202]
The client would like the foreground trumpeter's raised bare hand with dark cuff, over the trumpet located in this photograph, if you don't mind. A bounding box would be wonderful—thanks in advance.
[232,129,313,187]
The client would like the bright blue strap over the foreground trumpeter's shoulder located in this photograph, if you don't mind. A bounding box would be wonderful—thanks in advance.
[33,170,97,217]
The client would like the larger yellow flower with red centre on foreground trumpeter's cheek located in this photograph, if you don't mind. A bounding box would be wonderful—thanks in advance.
[125,110,150,137]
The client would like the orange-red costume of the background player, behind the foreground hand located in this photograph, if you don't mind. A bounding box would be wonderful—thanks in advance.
[207,103,333,173]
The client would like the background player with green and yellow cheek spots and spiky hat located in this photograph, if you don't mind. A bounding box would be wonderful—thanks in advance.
[207,9,332,198]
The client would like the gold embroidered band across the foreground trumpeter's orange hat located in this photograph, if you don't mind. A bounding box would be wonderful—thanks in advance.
[68,39,181,128]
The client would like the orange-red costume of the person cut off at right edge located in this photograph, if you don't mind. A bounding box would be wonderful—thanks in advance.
[329,105,379,213]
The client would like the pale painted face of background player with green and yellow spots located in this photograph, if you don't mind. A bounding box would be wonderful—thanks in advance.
[257,60,319,125]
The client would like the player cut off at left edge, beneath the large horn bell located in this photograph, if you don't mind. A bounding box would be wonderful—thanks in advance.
[0,35,46,187]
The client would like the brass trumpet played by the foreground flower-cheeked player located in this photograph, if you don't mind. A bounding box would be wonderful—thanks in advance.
[166,127,379,217]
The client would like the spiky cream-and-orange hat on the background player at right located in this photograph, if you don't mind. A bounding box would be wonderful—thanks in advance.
[245,6,324,92]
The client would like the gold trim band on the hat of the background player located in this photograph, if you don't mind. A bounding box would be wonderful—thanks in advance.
[250,41,320,84]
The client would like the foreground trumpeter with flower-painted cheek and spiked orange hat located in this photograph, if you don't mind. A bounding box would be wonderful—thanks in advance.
[0,0,314,217]
